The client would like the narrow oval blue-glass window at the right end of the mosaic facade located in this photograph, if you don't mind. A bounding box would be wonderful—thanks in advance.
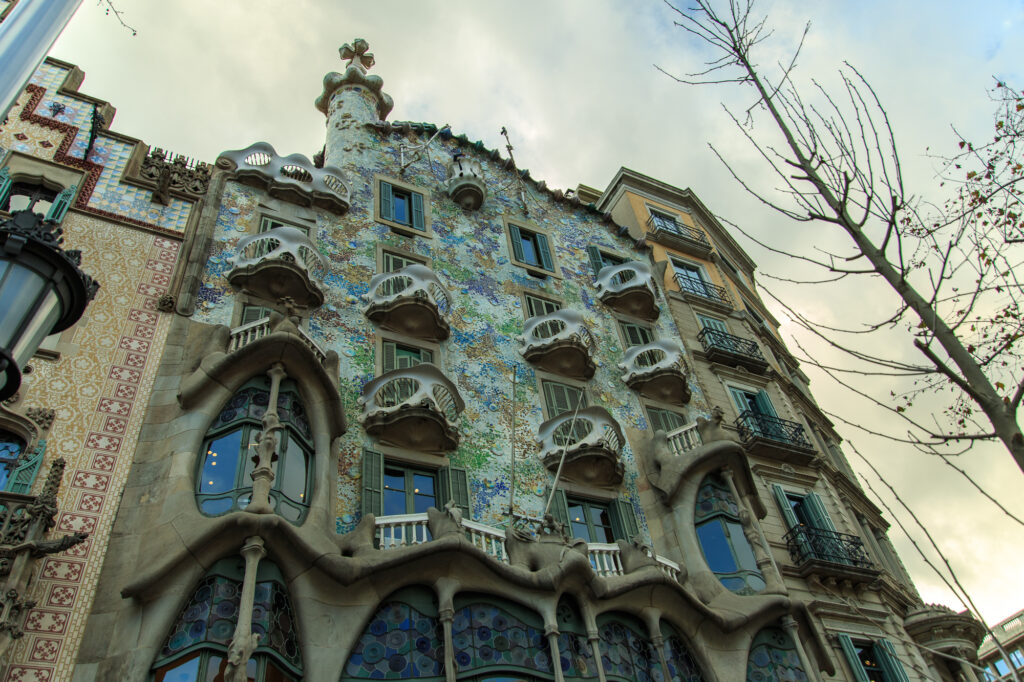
[693,474,765,595]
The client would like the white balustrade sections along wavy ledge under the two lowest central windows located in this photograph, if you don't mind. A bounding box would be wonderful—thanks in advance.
[376,514,680,581]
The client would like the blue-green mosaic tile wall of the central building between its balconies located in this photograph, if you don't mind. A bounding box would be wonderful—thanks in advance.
[186,128,708,532]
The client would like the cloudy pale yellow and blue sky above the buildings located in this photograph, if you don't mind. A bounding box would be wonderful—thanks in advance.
[51,0,1024,624]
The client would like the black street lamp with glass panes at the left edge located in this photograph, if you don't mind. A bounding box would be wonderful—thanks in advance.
[0,210,99,400]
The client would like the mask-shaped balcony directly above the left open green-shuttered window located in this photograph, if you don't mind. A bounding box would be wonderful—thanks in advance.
[359,364,466,453]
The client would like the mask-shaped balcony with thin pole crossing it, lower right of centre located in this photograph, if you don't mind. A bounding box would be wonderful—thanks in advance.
[537,408,625,485]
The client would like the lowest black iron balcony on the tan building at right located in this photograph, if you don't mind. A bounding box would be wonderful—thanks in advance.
[783,525,879,584]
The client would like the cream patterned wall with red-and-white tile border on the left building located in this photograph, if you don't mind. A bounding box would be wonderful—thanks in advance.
[6,212,179,682]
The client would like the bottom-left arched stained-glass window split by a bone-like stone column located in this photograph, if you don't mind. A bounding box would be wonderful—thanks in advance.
[153,557,302,682]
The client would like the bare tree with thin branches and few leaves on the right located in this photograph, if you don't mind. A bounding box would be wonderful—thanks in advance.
[667,0,1024,470]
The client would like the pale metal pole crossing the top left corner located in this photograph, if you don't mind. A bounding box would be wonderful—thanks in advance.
[0,0,82,121]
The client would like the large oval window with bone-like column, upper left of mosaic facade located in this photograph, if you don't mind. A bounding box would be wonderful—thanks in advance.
[196,377,313,523]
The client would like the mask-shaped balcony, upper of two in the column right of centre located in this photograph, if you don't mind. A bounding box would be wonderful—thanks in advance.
[519,310,596,381]
